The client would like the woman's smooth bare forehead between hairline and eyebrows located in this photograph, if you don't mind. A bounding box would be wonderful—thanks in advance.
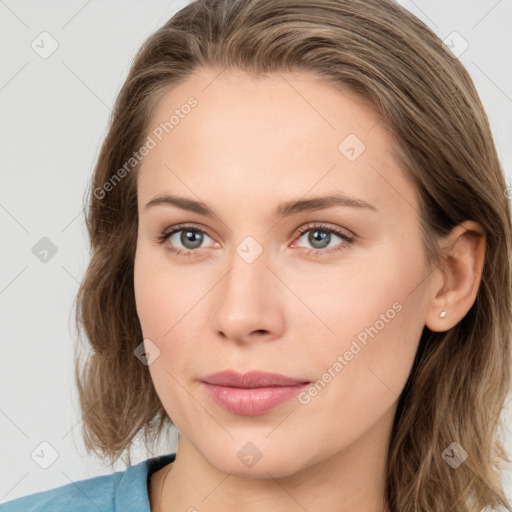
[139,69,415,218]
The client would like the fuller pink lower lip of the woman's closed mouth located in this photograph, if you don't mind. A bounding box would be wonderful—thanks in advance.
[203,382,309,416]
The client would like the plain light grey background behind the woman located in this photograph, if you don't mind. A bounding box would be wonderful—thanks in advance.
[0,0,512,502]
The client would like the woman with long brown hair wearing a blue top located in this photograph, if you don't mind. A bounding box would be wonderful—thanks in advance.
[0,0,511,512]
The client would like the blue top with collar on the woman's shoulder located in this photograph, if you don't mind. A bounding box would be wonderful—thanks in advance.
[0,453,176,512]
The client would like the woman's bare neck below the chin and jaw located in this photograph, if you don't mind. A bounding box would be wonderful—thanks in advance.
[151,408,395,512]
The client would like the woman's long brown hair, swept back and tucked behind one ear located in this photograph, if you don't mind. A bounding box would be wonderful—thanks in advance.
[76,0,512,512]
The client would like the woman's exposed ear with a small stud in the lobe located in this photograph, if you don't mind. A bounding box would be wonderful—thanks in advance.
[425,221,486,332]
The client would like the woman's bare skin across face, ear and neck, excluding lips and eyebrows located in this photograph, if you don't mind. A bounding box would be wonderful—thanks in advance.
[134,69,485,512]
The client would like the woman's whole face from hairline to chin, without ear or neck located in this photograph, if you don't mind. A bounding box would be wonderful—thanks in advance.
[134,70,429,476]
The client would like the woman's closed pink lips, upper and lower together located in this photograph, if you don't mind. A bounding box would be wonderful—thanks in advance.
[201,370,311,416]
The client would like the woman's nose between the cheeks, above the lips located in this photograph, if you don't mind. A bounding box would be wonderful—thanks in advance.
[213,244,285,343]
